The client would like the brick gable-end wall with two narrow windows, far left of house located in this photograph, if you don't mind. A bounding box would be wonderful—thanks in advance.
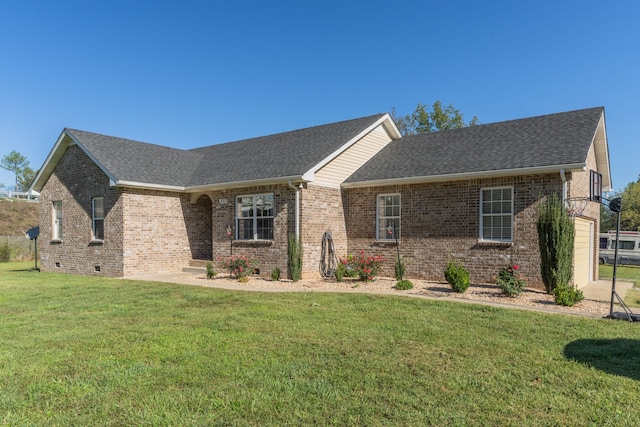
[38,145,123,276]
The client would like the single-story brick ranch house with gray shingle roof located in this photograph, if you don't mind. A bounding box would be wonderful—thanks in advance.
[32,107,611,286]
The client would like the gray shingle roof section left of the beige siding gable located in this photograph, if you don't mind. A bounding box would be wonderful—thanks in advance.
[65,114,384,187]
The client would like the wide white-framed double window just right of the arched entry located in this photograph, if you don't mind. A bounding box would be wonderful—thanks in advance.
[236,193,275,240]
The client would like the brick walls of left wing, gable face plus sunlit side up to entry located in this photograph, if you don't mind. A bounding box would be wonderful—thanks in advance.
[38,145,212,276]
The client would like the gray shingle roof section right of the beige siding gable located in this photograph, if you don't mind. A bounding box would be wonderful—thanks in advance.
[345,107,604,183]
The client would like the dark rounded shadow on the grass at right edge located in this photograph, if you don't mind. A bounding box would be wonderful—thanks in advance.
[564,338,640,381]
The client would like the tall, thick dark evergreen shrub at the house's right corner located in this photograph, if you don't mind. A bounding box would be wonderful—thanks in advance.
[537,194,575,294]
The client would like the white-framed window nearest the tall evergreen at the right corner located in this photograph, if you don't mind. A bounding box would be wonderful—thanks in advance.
[480,187,513,242]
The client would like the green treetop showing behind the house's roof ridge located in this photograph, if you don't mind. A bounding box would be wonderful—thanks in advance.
[391,101,479,136]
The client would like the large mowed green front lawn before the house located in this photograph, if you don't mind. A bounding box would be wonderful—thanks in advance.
[0,263,640,426]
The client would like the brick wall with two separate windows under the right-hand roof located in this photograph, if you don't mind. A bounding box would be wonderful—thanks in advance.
[343,174,562,287]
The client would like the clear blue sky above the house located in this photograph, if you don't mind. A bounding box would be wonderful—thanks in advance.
[0,0,640,190]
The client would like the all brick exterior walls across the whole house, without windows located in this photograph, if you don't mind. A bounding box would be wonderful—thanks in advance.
[38,145,599,287]
